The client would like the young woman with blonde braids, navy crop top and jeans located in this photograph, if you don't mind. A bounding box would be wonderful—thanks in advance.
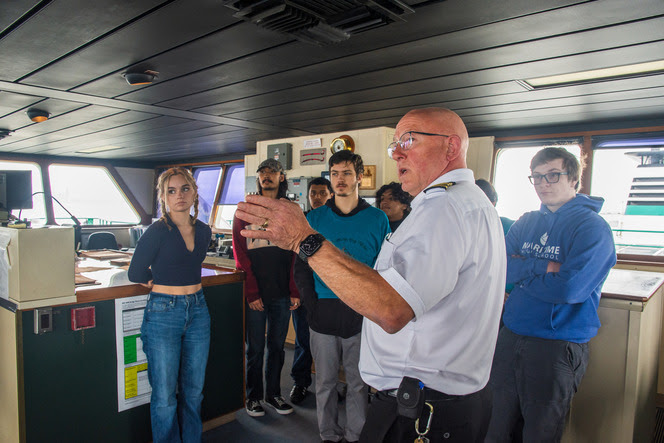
[128,168,212,443]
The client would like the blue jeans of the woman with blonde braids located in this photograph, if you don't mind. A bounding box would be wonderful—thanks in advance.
[141,290,210,443]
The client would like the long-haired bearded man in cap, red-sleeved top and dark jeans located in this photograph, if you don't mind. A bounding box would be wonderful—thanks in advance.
[233,159,300,417]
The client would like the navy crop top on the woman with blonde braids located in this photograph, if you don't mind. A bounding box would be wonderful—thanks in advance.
[128,218,212,286]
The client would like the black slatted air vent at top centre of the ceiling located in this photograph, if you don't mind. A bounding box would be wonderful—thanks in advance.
[224,0,415,45]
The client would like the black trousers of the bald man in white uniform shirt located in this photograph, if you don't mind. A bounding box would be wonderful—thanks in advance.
[360,386,492,443]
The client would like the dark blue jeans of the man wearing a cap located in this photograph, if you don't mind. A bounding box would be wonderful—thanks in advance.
[246,298,290,400]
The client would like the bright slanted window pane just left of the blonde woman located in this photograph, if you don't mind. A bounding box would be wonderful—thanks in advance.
[48,164,140,225]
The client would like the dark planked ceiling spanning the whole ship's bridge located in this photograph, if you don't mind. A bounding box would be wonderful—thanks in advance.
[0,0,664,162]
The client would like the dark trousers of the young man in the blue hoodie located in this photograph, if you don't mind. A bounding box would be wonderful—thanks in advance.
[486,327,589,443]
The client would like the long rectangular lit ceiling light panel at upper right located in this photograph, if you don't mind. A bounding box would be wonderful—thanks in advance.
[517,60,664,90]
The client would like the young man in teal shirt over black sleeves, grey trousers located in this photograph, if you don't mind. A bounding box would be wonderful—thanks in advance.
[295,151,390,442]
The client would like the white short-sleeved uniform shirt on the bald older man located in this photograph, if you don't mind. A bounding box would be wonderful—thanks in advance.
[360,169,506,395]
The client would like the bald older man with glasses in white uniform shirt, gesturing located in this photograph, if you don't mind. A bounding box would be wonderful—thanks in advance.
[237,108,506,442]
